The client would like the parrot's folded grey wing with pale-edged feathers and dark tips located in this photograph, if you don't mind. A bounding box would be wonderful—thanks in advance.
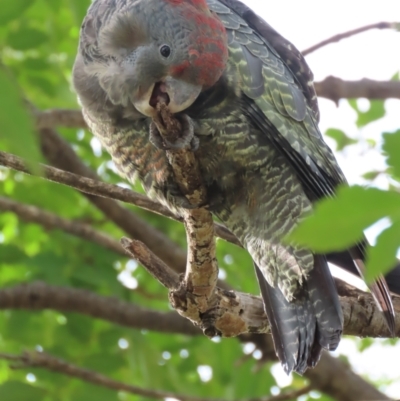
[208,0,346,200]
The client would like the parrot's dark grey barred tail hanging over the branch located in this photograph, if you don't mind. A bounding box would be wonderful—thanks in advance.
[255,255,343,374]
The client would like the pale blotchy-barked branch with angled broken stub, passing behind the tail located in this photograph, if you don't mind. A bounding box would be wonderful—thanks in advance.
[123,239,400,337]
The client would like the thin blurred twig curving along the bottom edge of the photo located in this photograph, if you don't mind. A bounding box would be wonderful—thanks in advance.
[0,351,312,401]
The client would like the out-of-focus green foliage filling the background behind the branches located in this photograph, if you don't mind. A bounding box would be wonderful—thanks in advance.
[0,0,400,401]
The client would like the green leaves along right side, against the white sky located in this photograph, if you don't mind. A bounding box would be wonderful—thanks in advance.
[288,100,400,282]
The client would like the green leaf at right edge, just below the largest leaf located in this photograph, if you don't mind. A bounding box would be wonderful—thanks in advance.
[365,220,400,282]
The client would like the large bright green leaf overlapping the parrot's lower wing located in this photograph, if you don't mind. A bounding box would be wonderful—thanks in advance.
[287,186,400,252]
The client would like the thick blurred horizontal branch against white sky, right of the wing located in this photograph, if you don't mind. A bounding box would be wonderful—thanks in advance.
[314,76,400,103]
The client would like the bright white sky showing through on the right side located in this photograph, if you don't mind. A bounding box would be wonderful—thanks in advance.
[242,0,400,398]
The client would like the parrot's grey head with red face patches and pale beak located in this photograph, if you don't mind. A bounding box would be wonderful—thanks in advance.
[80,0,228,117]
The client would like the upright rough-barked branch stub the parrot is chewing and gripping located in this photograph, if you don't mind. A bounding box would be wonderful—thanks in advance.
[153,103,218,306]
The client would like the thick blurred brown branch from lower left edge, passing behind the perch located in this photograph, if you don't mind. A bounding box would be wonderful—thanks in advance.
[0,282,394,401]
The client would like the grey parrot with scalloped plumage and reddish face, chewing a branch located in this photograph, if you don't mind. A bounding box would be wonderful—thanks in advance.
[73,0,400,374]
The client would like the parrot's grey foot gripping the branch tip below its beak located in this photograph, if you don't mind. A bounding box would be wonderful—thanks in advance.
[149,114,199,152]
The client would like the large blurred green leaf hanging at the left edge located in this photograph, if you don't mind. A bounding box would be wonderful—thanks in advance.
[0,69,40,169]
